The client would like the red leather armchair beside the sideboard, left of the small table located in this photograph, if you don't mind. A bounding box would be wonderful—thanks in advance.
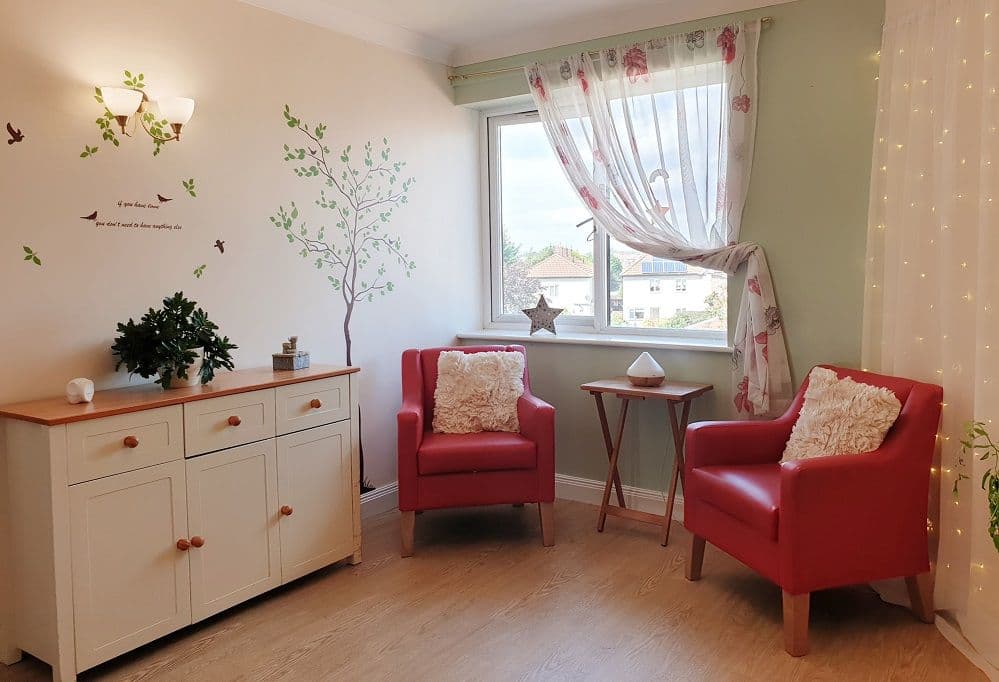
[398,346,555,557]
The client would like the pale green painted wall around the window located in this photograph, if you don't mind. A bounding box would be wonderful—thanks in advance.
[455,0,884,490]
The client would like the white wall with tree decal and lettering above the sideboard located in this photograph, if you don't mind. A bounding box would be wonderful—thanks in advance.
[0,0,481,660]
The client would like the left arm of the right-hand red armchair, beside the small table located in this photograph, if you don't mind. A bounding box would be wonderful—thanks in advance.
[684,416,794,471]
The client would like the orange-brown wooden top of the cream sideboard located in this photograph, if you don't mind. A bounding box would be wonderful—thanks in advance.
[0,365,360,426]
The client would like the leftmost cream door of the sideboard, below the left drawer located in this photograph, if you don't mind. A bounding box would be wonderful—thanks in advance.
[69,461,191,670]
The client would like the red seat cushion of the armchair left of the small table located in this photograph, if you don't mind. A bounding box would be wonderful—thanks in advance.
[416,431,538,476]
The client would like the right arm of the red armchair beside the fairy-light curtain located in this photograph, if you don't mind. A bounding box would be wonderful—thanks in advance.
[778,384,942,594]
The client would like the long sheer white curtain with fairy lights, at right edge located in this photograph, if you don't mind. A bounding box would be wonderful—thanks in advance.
[864,0,999,676]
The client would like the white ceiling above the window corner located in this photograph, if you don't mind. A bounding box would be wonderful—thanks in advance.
[244,0,792,66]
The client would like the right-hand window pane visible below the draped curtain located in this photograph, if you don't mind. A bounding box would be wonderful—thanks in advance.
[608,239,728,332]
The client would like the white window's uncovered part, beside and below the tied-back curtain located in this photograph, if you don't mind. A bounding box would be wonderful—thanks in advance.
[487,113,728,344]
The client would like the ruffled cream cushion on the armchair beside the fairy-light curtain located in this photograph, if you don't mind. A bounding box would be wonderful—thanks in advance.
[781,367,902,462]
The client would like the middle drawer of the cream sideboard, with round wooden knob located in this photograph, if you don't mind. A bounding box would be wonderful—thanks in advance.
[184,388,274,457]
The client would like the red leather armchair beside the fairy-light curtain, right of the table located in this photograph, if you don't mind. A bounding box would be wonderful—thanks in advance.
[684,367,943,656]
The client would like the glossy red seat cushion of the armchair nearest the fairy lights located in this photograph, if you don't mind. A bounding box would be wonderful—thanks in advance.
[688,462,780,540]
